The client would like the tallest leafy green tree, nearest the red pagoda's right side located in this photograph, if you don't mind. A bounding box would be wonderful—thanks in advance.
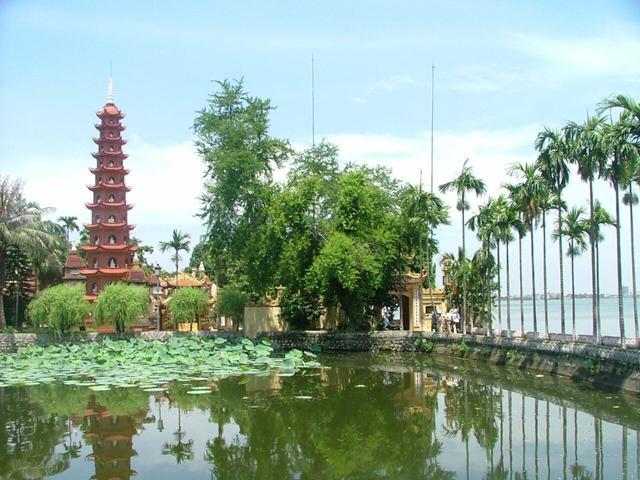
[193,80,290,285]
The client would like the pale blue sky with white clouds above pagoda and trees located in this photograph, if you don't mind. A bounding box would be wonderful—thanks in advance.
[0,0,640,291]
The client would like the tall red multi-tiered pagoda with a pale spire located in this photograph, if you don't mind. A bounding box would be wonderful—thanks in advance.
[80,81,136,298]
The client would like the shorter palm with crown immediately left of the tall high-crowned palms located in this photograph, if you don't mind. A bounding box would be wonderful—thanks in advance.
[505,163,548,334]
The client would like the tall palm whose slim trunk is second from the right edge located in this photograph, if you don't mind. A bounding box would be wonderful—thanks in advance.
[603,121,638,348]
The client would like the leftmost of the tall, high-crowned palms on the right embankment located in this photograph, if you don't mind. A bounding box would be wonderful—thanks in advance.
[535,128,570,335]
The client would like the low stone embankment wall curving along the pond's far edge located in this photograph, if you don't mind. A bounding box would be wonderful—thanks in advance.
[0,331,640,393]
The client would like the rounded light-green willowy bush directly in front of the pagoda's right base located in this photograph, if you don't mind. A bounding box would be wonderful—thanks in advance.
[94,283,149,332]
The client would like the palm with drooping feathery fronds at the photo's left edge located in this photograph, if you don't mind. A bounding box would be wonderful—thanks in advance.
[0,177,61,328]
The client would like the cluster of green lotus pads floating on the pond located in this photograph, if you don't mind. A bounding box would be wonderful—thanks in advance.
[0,337,320,391]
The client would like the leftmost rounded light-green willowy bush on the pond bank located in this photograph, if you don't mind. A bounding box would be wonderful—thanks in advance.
[27,285,91,335]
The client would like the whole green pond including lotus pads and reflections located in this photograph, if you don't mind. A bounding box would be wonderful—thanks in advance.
[0,338,640,479]
